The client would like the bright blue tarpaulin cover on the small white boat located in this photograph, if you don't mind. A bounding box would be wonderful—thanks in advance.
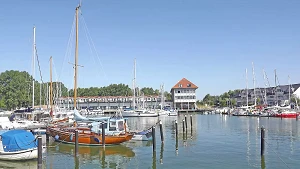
[1,130,37,152]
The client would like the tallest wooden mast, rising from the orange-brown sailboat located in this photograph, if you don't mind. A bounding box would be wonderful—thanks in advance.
[74,5,80,110]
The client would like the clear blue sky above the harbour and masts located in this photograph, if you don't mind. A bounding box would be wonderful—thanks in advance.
[0,0,300,99]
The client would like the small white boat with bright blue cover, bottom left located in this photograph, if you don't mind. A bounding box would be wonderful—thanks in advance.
[0,130,38,161]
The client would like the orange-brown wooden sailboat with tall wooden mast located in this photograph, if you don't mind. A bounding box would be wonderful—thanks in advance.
[47,4,133,146]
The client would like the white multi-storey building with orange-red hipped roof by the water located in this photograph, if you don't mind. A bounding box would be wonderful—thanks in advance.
[171,78,198,110]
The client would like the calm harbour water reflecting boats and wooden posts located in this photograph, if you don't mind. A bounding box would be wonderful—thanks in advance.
[0,114,300,169]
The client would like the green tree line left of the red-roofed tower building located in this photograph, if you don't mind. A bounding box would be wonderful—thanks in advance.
[0,70,171,110]
